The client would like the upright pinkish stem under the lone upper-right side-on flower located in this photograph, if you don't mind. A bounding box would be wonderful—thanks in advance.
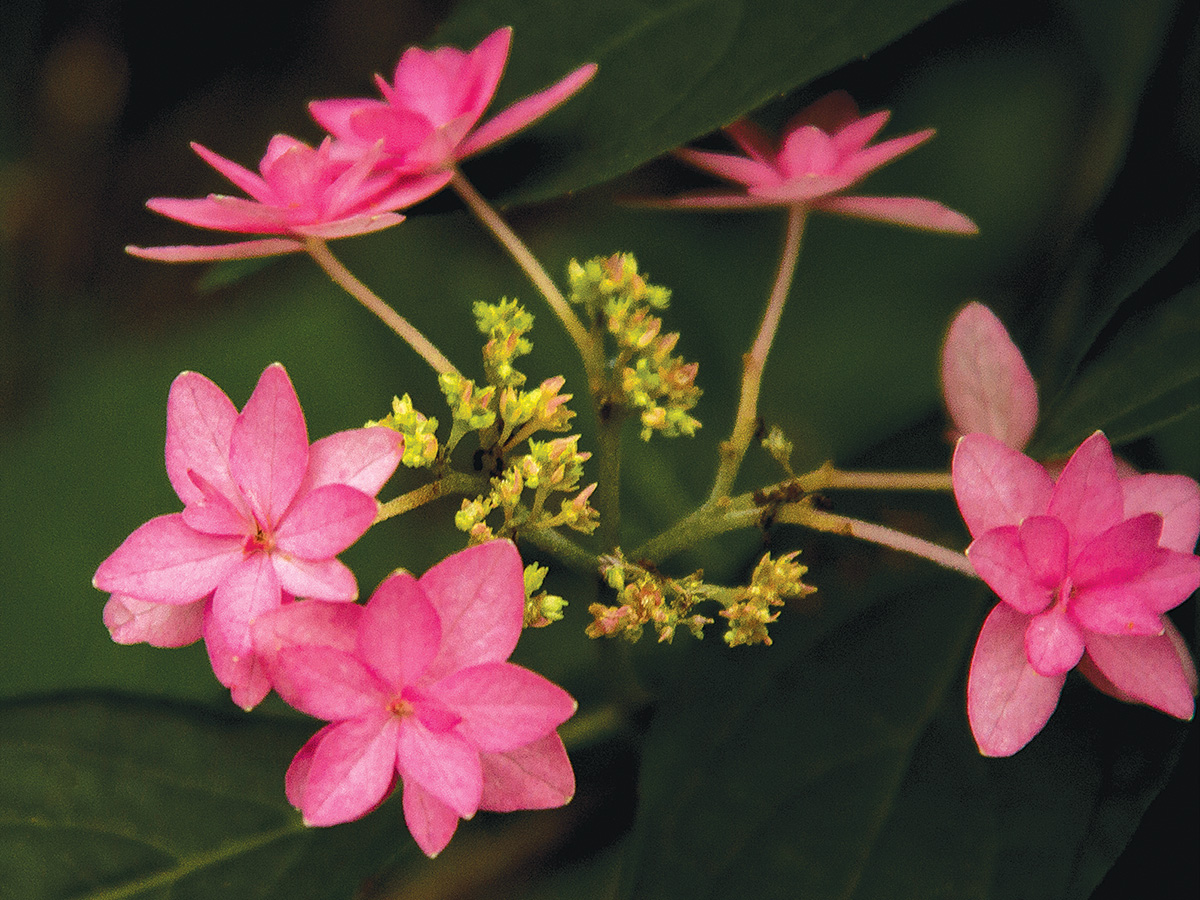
[709,205,808,502]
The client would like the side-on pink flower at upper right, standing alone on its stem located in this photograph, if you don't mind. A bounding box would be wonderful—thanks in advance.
[655,91,979,234]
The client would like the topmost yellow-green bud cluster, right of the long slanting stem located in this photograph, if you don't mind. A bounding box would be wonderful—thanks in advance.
[568,253,701,440]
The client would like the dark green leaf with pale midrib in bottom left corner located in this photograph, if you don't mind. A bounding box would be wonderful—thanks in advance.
[0,696,416,900]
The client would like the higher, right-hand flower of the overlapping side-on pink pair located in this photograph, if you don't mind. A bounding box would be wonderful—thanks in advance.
[308,28,596,179]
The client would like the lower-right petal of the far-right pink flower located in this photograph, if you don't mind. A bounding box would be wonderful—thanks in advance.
[1087,626,1195,719]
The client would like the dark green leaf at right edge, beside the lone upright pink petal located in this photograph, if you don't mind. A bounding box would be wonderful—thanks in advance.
[1032,284,1200,456]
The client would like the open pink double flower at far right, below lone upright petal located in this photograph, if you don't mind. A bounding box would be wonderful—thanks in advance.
[953,432,1200,756]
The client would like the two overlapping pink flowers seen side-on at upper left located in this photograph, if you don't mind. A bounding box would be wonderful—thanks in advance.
[127,28,596,263]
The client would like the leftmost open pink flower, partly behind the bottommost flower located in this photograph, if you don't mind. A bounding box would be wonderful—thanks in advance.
[92,364,403,709]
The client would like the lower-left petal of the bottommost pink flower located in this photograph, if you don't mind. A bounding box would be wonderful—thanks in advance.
[289,714,398,826]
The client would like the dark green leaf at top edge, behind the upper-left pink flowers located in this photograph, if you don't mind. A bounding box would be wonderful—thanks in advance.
[437,0,950,202]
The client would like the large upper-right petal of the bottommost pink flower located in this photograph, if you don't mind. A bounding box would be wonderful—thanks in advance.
[420,540,524,682]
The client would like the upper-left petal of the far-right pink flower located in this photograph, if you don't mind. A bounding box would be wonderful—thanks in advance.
[950,433,1054,538]
